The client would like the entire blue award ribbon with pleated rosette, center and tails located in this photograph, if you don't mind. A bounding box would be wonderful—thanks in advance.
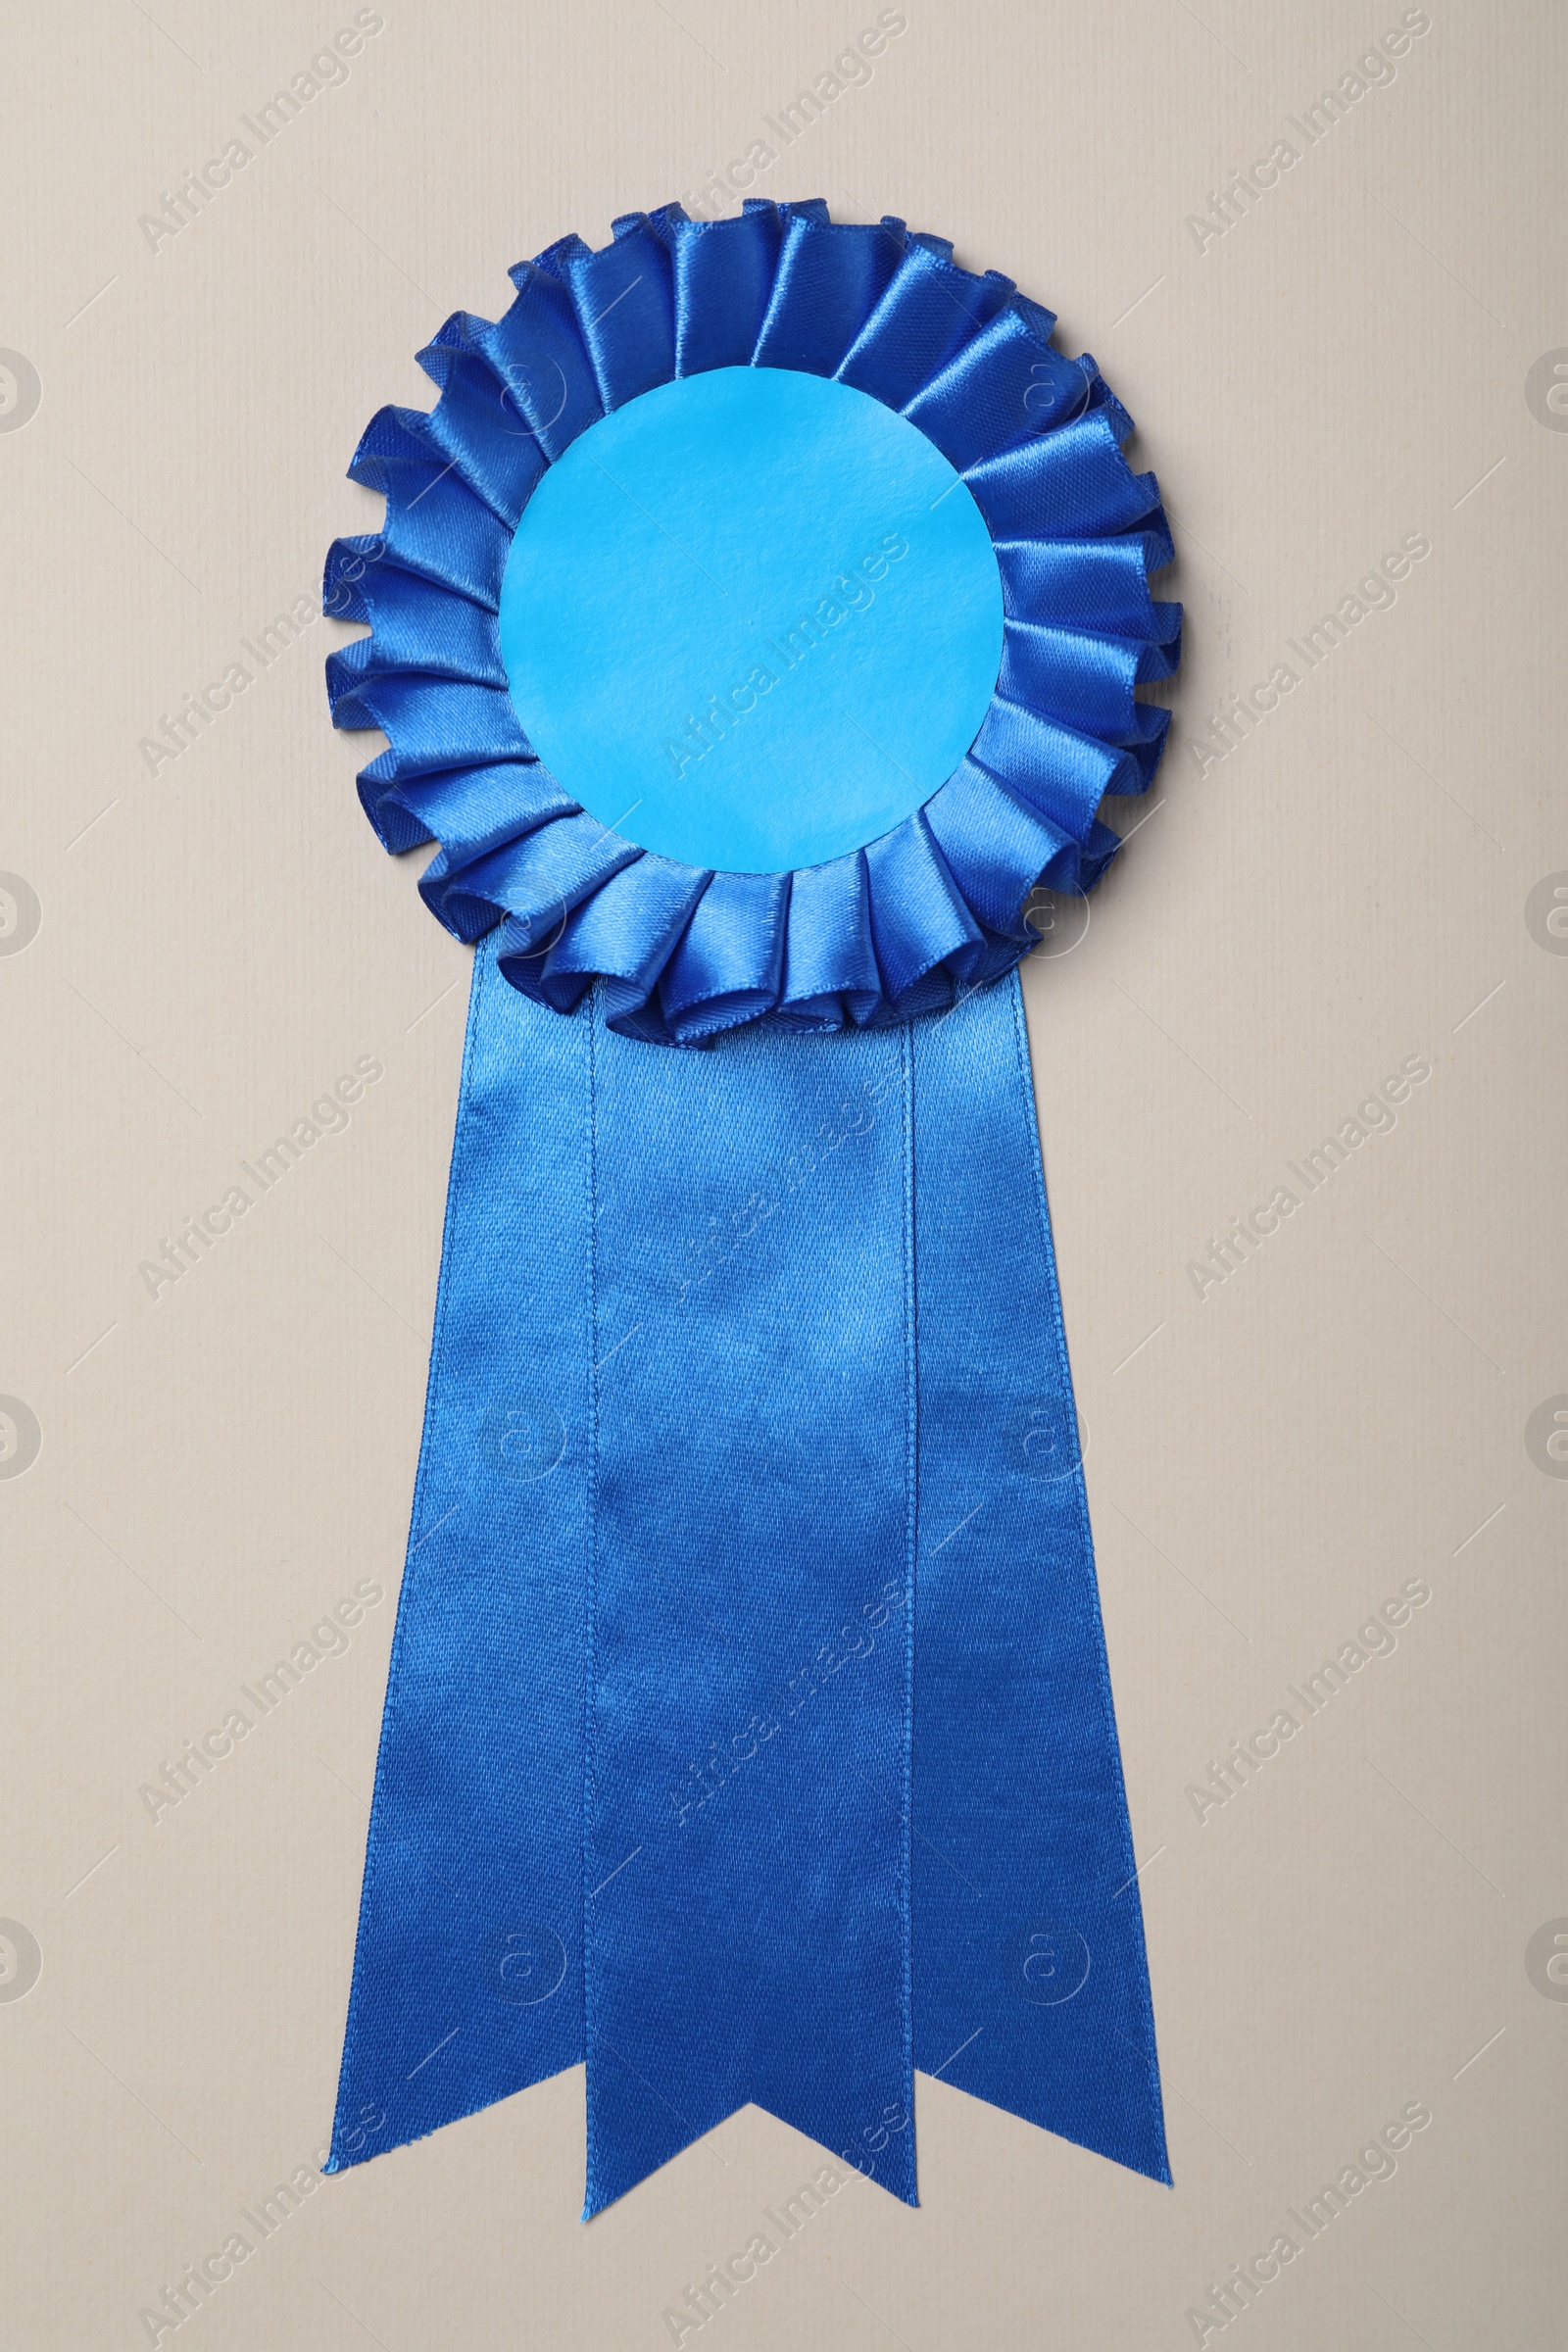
[324,200,1180,2213]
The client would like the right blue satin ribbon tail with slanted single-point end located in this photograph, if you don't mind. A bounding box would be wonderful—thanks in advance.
[912,974,1171,2182]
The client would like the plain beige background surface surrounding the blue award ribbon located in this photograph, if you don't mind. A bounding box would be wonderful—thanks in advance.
[0,0,1568,2352]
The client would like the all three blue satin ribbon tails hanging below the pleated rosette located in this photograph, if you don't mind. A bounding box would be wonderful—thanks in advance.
[331,941,1168,2213]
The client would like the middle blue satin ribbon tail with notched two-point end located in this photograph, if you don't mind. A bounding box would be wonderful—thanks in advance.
[585,1004,914,2213]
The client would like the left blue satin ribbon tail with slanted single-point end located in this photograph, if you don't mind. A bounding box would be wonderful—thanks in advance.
[326,946,588,2171]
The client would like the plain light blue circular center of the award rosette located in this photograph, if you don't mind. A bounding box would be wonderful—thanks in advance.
[501,367,1002,872]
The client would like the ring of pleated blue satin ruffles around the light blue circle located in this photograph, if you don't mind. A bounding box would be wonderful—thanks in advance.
[324,200,1180,1045]
